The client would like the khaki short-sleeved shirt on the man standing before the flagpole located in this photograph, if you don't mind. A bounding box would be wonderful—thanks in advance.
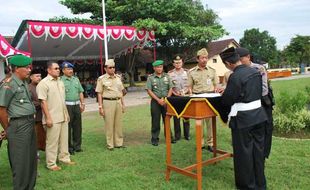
[96,74,124,98]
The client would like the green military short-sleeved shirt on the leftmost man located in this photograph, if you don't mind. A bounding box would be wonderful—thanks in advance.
[0,74,36,118]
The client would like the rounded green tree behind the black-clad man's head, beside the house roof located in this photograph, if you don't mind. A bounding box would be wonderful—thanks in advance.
[240,28,278,66]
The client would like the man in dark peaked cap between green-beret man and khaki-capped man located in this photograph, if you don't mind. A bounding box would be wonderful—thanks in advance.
[168,55,191,140]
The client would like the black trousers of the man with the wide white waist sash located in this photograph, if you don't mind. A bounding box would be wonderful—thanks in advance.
[232,122,266,190]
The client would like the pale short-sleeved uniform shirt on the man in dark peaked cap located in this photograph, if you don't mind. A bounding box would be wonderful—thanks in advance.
[168,68,189,95]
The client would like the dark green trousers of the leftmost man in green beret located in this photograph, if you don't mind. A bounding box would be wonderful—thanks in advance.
[7,116,37,190]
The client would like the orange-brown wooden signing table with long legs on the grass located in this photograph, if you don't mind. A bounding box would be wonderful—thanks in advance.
[165,98,233,190]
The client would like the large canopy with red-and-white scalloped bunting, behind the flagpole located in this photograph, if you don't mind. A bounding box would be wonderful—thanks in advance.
[12,20,155,60]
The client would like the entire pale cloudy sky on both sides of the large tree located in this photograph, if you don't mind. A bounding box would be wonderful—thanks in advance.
[0,0,310,49]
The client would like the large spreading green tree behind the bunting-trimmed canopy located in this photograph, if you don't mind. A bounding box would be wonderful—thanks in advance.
[60,0,227,84]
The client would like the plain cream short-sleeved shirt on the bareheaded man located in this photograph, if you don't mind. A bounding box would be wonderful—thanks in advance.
[36,75,69,124]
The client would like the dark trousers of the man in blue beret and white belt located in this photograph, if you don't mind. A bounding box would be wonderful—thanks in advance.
[67,105,82,151]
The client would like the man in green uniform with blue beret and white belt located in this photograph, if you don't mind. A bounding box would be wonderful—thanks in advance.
[61,61,85,155]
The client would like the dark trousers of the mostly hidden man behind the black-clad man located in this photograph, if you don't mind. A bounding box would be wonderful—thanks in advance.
[263,105,273,158]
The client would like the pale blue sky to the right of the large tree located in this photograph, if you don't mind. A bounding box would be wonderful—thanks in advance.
[202,0,310,50]
